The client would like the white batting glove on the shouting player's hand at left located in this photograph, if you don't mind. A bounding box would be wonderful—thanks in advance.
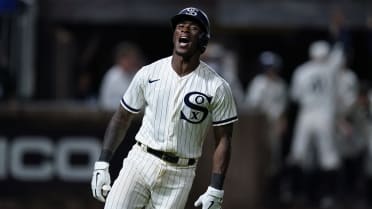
[91,161,111,202]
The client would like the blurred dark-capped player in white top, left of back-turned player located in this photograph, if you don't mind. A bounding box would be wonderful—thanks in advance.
[245,51,288,206]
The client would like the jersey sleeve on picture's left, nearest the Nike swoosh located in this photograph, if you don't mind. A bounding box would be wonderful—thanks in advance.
[120,68,145,113]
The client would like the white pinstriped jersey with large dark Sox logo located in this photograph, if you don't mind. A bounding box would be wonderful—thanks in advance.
[121,57,238,158]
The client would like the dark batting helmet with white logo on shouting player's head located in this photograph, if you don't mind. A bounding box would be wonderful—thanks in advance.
[171,7,211,52]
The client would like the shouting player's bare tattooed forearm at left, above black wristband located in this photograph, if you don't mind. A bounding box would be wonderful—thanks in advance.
[99,107,132,162]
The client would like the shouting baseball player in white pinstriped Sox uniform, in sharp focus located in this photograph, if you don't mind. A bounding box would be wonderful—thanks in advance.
[91,7,238,209]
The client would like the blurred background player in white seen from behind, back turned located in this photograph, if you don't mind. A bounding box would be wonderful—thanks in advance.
[288,40,343,208]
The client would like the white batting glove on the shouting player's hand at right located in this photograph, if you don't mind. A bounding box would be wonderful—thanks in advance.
[194,186,224,209]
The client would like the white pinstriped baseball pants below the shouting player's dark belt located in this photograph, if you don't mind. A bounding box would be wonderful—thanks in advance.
[105,144,196,209]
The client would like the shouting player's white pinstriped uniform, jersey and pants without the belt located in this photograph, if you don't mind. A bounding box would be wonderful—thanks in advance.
[105,57,237,209]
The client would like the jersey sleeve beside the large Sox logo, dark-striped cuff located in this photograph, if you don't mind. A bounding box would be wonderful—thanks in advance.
[212,83,238,126]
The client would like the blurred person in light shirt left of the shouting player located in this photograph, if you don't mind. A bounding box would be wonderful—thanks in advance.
[98,42,143,111]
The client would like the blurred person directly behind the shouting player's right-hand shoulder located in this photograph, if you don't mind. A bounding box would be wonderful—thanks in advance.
[201,42,244,107]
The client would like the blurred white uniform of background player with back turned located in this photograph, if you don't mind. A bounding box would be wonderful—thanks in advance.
[290,47,343,170]
